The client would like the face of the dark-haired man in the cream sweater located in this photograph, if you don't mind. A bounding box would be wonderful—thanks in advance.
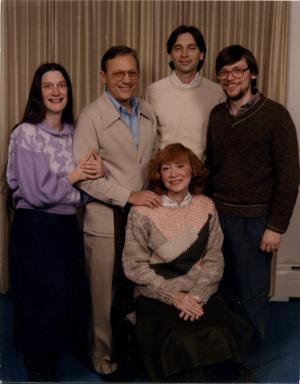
[171,32,204,78]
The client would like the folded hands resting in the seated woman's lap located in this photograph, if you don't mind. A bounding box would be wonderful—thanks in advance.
[173,292,204,321]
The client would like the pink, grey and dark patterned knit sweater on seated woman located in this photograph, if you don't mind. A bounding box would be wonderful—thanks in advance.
[123,195,224,304]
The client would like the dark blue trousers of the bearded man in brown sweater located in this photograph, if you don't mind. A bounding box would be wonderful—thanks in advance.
[219,214,272,338]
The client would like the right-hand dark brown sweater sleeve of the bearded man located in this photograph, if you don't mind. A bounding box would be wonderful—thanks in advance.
[267,103,300,233]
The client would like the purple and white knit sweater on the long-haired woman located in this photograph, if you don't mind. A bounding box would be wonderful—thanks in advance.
[7,121,85,214]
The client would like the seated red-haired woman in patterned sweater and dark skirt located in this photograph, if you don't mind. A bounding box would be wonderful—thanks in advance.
[123,144,252,382]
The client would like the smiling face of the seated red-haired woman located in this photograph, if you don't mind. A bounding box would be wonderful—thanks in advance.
[160,156,192,203]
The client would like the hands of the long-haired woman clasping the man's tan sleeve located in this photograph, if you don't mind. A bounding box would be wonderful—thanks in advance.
[68,151,106,184]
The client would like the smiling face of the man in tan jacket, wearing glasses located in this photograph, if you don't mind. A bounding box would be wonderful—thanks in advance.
[100,55,139,109]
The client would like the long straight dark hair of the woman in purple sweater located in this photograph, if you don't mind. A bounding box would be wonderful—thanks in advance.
[0,63,74,214]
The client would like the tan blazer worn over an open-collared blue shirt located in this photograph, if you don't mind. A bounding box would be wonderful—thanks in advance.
[73,93,157,237]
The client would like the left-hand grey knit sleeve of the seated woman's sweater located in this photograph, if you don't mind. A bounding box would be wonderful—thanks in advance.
[123,208,180,304]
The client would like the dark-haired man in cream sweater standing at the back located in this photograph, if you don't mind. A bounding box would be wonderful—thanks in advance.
[146,25,225,160]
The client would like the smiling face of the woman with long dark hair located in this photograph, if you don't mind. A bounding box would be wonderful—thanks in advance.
[41,71,68,116]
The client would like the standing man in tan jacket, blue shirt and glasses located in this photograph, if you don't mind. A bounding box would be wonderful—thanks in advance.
[74,46,160,380]
